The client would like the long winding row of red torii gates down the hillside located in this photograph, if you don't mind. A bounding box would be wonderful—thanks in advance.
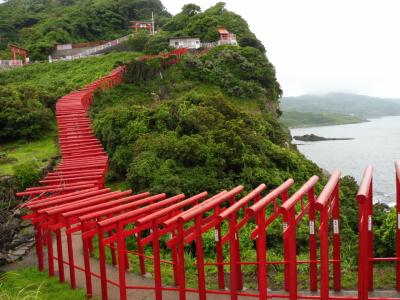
[18,49,400,300]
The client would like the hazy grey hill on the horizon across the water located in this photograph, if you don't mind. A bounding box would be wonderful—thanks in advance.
[280,93,400,118]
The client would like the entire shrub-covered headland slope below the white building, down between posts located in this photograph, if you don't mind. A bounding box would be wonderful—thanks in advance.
[91,47,388,287]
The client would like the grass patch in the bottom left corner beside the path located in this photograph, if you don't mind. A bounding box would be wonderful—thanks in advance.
[0,268,86,300]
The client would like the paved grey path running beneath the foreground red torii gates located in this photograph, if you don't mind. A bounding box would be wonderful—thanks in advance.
[1,233,400,300]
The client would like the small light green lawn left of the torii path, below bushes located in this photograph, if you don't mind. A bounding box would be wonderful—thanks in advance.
[0,130,58,175]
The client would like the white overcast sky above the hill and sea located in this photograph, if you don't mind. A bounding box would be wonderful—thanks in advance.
[162,0,400,98]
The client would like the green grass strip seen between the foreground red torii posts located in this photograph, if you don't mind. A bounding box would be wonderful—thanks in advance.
[90,231,396,291]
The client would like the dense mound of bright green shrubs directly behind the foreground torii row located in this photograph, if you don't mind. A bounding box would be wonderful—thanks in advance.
[94,92,319,194]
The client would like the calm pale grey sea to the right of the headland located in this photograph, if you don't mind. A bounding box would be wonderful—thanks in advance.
[291,116,400,205]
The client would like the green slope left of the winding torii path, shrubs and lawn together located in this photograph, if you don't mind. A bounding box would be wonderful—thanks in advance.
[0,52,139,183]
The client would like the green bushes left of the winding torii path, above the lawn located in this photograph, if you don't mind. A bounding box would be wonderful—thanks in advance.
[0,52,139,143]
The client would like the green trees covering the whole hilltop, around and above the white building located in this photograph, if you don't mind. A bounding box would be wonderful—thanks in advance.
[0,0,265,60]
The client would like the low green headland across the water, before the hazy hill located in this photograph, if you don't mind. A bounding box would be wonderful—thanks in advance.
[280,111,368,128]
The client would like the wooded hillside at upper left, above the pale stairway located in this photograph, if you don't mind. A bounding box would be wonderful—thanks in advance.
[0,0,170,60]
